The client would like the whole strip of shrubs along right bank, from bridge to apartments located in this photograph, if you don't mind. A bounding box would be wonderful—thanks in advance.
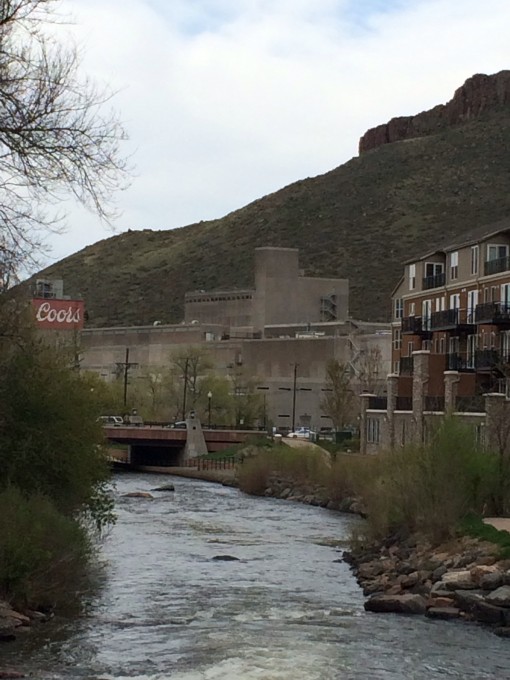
[239,418,510,542]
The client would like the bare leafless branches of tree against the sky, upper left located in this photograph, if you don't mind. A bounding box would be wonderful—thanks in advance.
[0,0,127,288]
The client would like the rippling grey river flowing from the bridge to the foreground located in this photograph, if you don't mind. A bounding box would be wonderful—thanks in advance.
[0,474,510,680]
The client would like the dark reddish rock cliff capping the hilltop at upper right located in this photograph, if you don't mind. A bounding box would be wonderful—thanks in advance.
[359,71,510,154]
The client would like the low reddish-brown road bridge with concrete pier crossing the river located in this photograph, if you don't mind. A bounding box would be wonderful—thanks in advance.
[103,418,265,467]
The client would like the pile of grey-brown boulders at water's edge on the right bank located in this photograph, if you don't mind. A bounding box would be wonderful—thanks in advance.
[343,537,510,637]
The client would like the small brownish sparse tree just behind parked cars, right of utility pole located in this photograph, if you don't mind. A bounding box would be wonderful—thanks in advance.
[321,359,358,429]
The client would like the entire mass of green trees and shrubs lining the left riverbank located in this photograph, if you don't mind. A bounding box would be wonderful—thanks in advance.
[0,310,113,609]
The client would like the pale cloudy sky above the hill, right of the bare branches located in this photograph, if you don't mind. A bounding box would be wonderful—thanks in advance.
[41,0,510,263]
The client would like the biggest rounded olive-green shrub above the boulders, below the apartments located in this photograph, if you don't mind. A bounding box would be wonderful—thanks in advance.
[355,418,495,540]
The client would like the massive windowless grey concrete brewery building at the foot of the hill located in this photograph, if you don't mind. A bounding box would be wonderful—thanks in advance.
[81,248,391,428]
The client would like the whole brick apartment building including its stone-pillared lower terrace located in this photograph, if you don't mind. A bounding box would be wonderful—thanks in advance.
[361,219,510,452]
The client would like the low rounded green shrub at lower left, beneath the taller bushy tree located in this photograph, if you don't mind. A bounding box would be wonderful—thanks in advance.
[0,487,92,608]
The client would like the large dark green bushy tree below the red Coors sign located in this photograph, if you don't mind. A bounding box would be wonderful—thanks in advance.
[0,331,109,524]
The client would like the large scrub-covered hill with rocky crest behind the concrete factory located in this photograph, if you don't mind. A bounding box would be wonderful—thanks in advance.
[33,71,510,326]
